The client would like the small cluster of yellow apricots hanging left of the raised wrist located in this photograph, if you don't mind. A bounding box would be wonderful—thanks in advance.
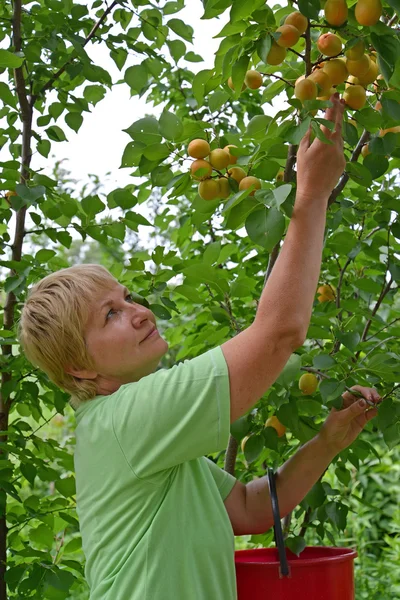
[188,139,261,200]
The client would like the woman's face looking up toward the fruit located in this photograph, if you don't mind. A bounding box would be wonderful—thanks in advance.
[78,282,168,393]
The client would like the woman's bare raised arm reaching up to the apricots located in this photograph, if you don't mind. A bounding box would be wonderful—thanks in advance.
[222,94,346,422]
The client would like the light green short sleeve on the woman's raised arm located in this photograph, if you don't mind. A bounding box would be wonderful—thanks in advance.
[112,347,230,477]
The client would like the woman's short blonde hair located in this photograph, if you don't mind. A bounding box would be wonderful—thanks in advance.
[19,264,117,408]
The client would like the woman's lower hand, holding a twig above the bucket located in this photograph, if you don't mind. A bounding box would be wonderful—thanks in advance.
[318,385,381,454]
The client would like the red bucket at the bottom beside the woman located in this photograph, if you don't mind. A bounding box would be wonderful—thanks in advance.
[235,546,357,600]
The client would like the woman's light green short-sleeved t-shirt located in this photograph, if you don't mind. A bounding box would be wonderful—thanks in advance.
[75,348,236,600]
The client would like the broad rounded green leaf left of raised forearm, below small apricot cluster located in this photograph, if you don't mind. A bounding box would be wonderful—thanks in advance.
[245,207,285,252]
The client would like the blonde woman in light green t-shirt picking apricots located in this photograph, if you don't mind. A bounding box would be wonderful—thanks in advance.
[20,95,379,600]
